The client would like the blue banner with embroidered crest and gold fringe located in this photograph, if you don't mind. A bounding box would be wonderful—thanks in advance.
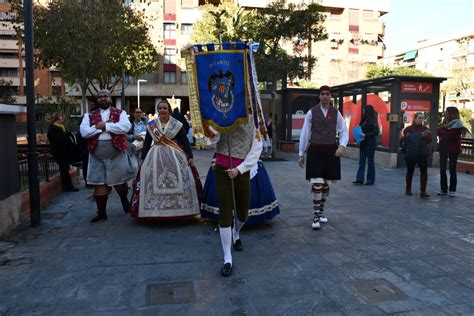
[195,50,248,132]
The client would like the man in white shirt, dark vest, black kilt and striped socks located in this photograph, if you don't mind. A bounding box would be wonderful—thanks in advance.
[298,86,349,229]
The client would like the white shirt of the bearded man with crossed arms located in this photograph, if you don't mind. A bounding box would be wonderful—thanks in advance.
[80,107,132,140]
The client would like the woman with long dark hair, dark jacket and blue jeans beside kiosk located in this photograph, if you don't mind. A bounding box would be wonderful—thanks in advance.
[352,104,380,185]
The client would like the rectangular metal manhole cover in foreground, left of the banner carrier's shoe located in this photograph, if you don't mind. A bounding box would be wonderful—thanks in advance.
[146,282,196,305]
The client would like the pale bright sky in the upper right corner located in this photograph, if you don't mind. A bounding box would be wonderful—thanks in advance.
[381,0,474,56]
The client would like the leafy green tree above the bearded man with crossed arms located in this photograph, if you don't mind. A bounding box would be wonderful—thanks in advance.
[10,0,158,111]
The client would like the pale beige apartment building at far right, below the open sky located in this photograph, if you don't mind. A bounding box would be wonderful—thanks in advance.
[379,32,474,110]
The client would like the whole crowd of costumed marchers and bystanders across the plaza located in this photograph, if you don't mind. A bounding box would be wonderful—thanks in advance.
[48,86,465,277]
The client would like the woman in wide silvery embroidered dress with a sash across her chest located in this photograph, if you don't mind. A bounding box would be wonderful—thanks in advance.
[130,100,199,218]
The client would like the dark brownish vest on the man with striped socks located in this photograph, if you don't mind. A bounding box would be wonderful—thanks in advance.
[309,104,338,145]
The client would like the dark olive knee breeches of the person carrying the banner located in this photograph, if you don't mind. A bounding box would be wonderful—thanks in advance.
[215,166,250,227]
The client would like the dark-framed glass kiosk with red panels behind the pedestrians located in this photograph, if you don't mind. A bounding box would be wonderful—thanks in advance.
[281,76,446,168]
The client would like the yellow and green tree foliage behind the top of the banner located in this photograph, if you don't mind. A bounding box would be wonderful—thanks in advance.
[193,0,327,86]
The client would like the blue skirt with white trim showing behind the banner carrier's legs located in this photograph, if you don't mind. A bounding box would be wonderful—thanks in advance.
[201,160,280,225]
